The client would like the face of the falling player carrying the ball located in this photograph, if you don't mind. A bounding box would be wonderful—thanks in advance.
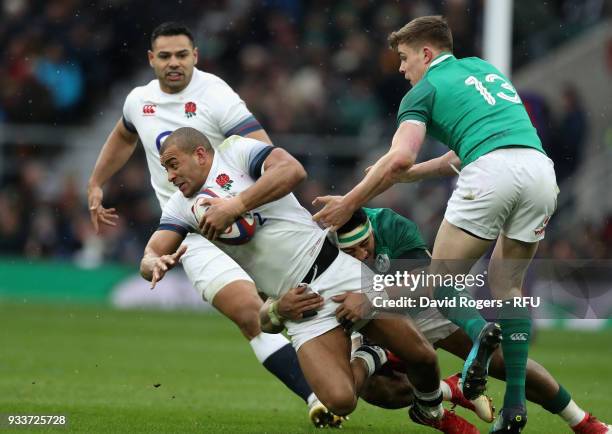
[160,146,211,197]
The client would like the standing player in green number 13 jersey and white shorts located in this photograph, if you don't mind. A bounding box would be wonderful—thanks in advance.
[314,16,558,433]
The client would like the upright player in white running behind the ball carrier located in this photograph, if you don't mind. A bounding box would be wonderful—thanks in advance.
[88,23,330,426]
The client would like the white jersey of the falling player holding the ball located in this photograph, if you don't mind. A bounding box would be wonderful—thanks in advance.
[160,136,327,297]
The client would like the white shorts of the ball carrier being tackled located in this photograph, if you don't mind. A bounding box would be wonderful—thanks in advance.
[285,251,373,351]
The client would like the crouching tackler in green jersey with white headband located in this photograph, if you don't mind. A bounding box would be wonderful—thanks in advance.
[336,208,612,434]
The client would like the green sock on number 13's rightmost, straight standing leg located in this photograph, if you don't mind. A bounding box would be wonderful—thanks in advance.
[499,304,531,408]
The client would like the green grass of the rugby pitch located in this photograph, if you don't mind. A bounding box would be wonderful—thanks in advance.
[0,304,612,434]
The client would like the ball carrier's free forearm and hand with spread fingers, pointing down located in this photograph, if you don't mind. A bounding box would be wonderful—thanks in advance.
[140,229,187,289]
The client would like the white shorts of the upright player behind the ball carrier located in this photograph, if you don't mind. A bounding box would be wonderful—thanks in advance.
[181,233,253,304]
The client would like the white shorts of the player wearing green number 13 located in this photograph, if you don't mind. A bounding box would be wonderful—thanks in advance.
[444,147,559,243]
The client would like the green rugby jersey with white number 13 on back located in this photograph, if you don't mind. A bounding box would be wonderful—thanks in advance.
[397,53,545,167]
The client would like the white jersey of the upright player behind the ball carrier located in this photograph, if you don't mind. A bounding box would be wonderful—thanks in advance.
[123,68,261,208]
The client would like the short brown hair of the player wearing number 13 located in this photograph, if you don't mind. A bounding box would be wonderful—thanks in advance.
[387,15,453,51]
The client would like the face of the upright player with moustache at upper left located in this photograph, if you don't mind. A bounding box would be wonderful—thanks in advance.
[148,35,198,93]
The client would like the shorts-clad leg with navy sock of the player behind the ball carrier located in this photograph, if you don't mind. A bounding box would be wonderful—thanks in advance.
[182,235,316,404]
